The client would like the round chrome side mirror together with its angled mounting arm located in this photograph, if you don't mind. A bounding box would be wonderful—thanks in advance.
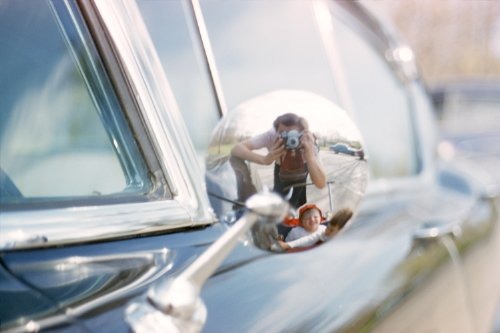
[126,91,367,333]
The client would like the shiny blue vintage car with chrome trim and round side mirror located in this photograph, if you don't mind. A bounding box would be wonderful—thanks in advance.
[0,0,500,333]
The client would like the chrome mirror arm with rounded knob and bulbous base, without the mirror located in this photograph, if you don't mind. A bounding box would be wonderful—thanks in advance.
[125,191,290,333]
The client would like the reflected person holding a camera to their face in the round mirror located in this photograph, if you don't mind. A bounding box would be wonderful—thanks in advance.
[231,113,326,208]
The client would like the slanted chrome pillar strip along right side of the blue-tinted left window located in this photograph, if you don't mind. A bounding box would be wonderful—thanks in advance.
[95,0,214,218]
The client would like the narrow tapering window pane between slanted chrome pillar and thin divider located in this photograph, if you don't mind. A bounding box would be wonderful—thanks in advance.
[138,0,219,166]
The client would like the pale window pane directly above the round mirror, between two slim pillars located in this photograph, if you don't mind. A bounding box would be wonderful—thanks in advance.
[201,1,338,110]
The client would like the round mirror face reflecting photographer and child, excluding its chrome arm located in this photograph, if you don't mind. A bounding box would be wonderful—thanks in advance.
[206,90,368,252]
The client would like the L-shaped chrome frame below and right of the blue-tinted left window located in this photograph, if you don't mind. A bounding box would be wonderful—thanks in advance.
[0,0,216,250]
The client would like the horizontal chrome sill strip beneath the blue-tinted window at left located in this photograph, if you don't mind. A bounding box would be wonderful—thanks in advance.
[0,200,196,250]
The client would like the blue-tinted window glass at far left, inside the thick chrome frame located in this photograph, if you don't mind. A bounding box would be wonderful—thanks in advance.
[0,0,151,204]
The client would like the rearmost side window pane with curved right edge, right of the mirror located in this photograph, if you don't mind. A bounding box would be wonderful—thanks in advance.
[332,8,418,178]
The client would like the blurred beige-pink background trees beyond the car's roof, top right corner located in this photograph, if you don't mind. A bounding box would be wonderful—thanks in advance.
[378,0,500,85]
